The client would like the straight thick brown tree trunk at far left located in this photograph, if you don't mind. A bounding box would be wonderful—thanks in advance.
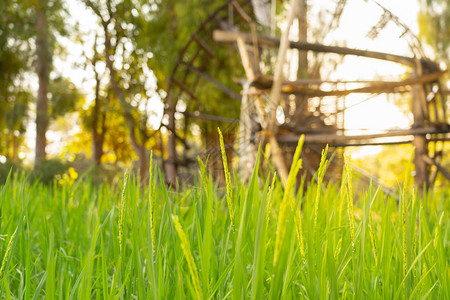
[35,0,50,165]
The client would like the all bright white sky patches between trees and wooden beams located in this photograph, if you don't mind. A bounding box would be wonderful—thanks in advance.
[27,0,426,162]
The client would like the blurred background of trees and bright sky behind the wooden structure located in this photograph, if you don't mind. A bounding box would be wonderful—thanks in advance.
[0,0,450,189]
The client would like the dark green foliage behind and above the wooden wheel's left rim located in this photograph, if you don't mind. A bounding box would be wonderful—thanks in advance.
[146,0,243,123]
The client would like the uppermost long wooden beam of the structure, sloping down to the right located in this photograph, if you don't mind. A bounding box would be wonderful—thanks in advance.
[213,30,434,67]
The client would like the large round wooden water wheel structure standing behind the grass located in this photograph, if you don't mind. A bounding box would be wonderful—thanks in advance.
[165,0,450,188]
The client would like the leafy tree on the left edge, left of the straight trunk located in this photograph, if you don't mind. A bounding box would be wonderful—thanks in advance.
[0,0,32,162]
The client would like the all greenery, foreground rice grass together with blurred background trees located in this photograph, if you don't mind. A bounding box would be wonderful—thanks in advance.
[0,0,450,299]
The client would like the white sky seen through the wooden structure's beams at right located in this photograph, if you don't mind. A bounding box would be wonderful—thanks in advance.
[334,0,419,158]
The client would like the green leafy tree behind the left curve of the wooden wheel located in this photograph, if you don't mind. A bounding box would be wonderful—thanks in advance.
[146,0,243,185]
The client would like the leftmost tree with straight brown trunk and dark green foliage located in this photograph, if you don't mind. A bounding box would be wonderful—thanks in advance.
[0,0,72,165]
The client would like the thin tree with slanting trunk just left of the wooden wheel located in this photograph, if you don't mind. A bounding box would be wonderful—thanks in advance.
[83,0,160,182]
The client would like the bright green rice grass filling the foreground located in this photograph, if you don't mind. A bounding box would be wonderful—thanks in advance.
[0,145,450,299]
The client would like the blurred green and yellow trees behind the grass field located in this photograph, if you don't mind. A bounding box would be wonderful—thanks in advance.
[0,0,450,184]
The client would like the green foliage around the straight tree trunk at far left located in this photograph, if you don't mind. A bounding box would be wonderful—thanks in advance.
[0,0,75,159]
